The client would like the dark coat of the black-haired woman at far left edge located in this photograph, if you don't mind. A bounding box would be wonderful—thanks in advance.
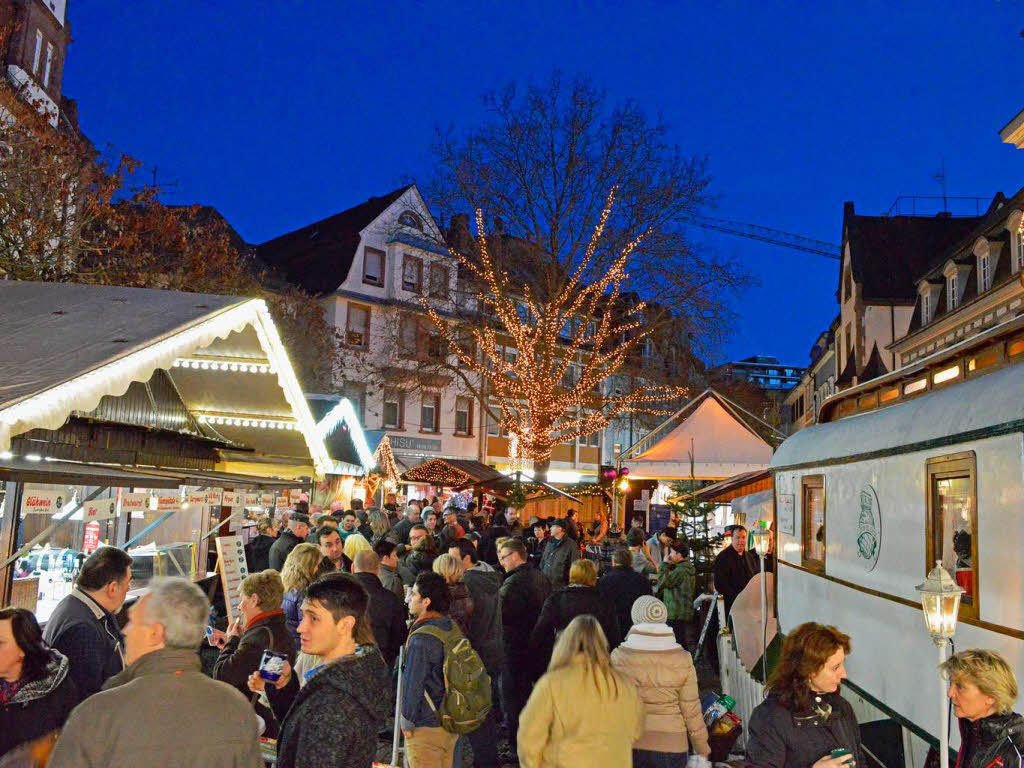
[0,650,78,756]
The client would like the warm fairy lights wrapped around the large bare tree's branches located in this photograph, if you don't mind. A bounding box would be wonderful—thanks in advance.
[423,187,687,463]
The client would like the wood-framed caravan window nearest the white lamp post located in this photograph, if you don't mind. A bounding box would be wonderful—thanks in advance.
[925,452,978,618]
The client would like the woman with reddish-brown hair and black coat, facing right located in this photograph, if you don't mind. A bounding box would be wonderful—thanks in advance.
[744,622,867,768]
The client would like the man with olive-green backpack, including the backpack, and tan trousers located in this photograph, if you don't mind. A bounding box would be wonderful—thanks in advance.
[401,571,490,768]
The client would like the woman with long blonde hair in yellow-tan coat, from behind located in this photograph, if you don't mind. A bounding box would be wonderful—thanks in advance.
[518,615,644,768]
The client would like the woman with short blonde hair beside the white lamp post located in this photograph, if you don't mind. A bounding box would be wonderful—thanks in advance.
[939,649,1024,768]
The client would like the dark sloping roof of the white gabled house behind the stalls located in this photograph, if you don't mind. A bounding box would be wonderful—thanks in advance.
[256,184,422,294]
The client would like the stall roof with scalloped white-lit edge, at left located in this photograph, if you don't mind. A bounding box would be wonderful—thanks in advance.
[0,281,333,474]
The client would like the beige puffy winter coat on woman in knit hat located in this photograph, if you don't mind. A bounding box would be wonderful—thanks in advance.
[611,624,711,757]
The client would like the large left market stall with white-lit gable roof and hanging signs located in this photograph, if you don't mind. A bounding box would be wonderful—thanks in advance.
[0,282,335,604]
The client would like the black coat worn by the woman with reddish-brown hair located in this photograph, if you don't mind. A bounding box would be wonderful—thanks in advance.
[743,692,864,768]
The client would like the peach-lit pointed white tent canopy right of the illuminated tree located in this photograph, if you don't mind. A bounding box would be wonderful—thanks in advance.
[623,390,772,479]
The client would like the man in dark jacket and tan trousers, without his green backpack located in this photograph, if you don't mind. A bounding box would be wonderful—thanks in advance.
[401,571,459,768]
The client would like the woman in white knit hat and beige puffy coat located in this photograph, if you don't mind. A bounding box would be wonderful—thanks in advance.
[611,595,711,768]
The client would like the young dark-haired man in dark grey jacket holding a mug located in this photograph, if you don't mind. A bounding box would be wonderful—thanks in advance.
[260,573,394,768]
